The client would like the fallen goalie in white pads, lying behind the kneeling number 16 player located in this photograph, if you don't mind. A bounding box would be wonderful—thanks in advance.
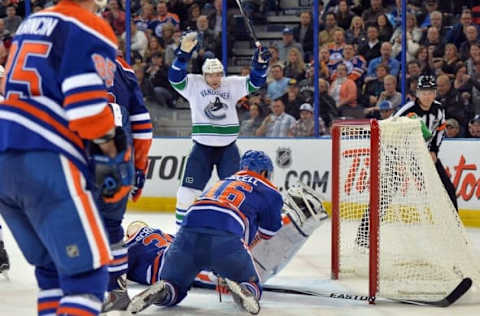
[122,184,327,312]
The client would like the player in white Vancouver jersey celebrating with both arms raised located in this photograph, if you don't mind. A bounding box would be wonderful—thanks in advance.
[168,32,270,225]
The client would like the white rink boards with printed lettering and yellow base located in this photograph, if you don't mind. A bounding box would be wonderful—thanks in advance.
[129,137,480,227]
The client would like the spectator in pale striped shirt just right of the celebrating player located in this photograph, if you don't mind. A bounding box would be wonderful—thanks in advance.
[256,99,295,137]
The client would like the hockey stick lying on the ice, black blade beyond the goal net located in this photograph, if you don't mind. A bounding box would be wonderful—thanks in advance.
[263,278,472,307]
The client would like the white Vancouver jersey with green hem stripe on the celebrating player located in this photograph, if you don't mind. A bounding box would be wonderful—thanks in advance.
[169,71,258,146]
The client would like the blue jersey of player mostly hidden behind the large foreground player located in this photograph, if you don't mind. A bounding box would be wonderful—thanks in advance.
[108,57,153,172]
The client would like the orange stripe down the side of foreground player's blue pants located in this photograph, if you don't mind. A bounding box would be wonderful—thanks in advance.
[68,161,110,265]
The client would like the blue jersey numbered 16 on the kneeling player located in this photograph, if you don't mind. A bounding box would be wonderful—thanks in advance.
[182,170,283,245]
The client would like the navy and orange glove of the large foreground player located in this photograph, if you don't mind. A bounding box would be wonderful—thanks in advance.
[90,127,133,203]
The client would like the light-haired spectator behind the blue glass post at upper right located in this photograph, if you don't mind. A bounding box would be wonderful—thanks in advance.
[390,13,423,62]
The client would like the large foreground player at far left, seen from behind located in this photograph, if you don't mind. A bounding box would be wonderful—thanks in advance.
[0,0,130,315]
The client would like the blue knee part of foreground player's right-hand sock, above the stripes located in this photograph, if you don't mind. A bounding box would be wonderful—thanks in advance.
[59,266,108,302]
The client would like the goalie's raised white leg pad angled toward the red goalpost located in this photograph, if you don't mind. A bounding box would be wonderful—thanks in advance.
[251,181,328,282]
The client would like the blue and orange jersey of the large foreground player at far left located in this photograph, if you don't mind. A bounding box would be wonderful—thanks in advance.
[0,0,117,175]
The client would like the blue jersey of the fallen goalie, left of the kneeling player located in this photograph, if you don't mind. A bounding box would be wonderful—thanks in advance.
[126,226,174,285]
